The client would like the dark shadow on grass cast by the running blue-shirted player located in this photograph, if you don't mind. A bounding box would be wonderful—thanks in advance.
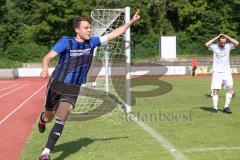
[53,137,128,160]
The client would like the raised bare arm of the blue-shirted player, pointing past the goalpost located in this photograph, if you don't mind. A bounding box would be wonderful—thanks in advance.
[107,9,140,41]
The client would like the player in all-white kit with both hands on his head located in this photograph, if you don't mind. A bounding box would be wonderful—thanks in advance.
[205,34,239,114]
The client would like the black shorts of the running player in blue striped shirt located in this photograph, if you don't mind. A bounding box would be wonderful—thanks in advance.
[45,78,80,111]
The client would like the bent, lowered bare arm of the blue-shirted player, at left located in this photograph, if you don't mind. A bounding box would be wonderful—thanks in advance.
[40,50,57,78]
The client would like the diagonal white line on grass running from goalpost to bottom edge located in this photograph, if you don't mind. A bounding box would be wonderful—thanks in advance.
[128,114,188,160]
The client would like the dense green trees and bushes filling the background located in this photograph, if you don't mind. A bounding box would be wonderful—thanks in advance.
[0,0,240,65]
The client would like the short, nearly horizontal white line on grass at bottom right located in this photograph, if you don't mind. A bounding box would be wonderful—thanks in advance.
[184,147,240,153]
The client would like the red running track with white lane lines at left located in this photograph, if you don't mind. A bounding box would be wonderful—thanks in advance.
[0,78,48,160]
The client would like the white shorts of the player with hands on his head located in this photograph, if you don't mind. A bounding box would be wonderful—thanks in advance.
[211,72,233,90]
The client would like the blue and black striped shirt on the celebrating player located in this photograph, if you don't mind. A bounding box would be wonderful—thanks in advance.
[52,36,101,85]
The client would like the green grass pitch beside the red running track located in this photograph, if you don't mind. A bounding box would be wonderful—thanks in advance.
[19,77,240,160]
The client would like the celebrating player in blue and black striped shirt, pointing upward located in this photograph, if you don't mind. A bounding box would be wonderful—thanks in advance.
[38,10,140,160]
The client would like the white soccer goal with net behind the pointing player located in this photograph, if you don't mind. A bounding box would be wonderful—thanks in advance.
[69,7,131,120]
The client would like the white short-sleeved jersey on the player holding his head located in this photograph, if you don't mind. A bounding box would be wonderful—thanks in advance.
[209,43,234,73]
